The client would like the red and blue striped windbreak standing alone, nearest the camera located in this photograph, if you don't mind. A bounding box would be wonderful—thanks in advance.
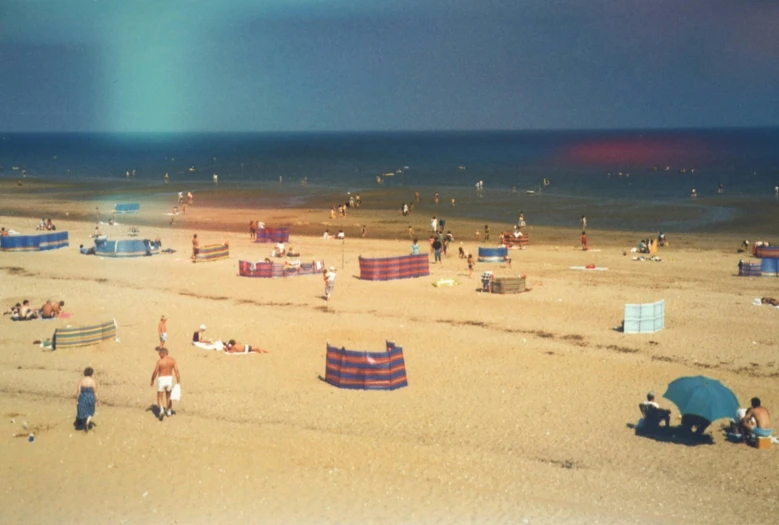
[325,341,408,390]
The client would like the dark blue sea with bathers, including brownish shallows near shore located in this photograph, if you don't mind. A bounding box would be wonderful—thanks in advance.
[0,128,779,233]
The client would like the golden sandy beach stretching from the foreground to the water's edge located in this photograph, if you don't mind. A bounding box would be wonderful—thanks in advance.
[0,182,779,524]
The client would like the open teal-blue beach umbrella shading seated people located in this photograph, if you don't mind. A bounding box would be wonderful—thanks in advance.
[663,376,739,421]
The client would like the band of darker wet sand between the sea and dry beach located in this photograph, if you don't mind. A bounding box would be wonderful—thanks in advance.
[0,179,779,248]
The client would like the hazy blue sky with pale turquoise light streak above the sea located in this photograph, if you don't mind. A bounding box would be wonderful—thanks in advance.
[0,0,779,132]
